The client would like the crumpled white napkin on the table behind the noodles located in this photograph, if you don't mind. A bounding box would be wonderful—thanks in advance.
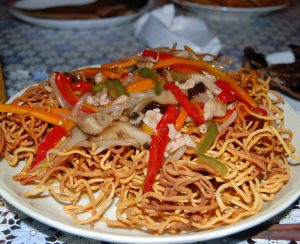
[134,4,222,55]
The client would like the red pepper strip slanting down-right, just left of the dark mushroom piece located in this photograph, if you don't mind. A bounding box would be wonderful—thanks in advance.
[164,82,205,124]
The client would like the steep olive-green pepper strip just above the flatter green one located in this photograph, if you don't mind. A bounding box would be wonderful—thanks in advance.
[196,121,218,155]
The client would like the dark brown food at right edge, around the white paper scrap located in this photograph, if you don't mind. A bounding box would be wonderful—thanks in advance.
[243,45,300,100]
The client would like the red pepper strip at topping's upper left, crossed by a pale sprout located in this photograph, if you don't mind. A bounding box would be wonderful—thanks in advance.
[55,72,95,113]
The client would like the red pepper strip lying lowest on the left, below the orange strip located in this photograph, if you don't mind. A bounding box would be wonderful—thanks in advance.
[29,125,69,170]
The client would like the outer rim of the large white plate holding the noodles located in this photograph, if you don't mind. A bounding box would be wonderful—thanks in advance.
[0,83,300,243]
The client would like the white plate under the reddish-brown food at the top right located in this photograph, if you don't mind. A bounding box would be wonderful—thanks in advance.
[171,0,289,20]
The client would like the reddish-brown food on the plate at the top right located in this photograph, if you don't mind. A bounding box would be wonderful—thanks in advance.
[181,0,290,8]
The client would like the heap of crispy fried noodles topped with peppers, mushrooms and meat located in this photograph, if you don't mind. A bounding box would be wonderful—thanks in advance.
[0,47,299,234]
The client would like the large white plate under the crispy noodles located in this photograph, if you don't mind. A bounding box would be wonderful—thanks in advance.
[0,84,300,243]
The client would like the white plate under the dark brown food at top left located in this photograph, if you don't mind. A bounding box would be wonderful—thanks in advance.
[9,0,153,29]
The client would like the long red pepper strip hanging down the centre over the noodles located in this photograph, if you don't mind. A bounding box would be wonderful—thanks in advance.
[144,104,179,192]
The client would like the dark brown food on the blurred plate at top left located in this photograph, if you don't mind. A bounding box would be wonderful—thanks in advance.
[17,0,148,19]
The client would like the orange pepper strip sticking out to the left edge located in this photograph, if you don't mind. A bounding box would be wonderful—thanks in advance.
[0,104,74,130]
